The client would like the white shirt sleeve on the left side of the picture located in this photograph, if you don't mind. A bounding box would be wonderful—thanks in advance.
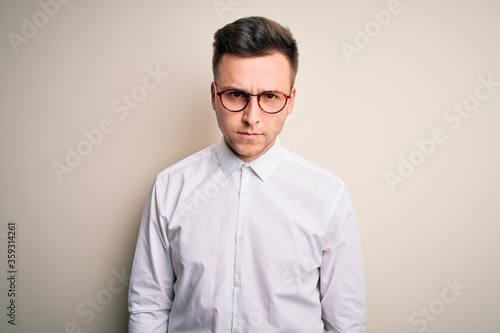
[128,179,175,333]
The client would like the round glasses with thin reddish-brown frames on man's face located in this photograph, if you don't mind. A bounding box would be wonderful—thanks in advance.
[214,82,290,114]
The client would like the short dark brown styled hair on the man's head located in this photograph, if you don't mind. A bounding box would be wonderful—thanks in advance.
[212,16,299,85]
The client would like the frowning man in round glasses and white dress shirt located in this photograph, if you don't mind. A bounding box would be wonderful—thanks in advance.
[129,17,366,333]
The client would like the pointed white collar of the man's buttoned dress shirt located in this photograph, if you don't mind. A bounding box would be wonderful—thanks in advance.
[217,138,283,182]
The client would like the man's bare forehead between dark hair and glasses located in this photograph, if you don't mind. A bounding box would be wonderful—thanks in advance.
[217,52,292,90]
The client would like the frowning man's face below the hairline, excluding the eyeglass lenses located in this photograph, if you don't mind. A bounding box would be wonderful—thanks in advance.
[211,53,295,162]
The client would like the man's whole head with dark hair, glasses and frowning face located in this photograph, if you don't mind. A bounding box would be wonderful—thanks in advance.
[211,17,298,162]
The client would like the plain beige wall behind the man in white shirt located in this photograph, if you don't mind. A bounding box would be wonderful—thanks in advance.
[0,0,500,333]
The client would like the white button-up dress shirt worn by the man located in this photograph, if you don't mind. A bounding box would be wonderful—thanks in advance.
[129,139,366,333]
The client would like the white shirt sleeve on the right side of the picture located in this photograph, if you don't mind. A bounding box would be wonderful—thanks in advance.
[320,187,366,333]
